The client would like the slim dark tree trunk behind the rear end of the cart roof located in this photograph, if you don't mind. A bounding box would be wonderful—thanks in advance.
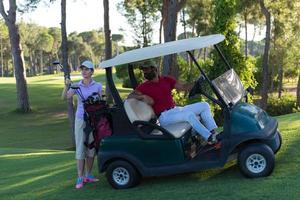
[103,0,113,103]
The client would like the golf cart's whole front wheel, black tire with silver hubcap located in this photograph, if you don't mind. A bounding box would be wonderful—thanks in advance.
[238,144,275,178]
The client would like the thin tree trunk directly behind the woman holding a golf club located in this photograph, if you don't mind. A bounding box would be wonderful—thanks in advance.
[61,0,75,147]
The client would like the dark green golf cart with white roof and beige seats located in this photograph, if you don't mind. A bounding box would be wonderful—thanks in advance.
[97,34,281,189]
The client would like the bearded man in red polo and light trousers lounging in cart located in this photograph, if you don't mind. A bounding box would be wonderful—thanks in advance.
[128,61,217,144]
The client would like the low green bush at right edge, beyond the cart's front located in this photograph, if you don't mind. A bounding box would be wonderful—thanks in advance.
[267,94,300,116]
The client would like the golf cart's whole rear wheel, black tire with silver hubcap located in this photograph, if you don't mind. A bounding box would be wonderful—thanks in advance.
[106,160,140,189]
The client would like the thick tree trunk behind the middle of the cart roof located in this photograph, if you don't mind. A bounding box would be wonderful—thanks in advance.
[162,0,186,78]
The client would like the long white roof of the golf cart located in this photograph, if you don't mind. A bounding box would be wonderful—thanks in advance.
[99,34,225,68]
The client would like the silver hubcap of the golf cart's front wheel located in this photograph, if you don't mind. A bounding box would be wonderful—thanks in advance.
[246,154,267,173]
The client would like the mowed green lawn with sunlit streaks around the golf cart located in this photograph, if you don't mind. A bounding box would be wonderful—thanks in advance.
[0,71,300,200]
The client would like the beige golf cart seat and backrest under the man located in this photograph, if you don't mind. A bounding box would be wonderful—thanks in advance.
[124,98,191,138]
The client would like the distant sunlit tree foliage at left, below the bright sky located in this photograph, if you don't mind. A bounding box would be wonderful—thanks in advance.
[0,20,123,76]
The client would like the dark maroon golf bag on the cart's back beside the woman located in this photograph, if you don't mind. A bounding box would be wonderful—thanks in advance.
[83,96,112,152]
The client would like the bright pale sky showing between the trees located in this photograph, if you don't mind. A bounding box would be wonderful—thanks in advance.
[18,0,264,46]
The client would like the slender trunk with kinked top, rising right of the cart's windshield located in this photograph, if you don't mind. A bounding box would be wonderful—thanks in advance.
[259,0,271,109]
